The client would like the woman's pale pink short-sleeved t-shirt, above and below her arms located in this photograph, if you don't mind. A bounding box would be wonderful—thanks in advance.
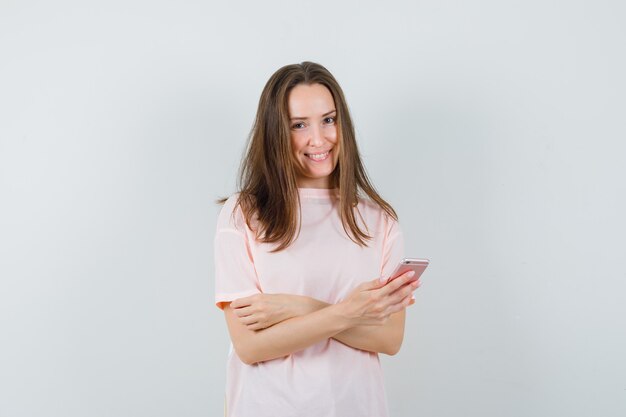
[215,188,404,417]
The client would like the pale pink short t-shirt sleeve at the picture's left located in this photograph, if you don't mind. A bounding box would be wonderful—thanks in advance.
[214,196,261,309]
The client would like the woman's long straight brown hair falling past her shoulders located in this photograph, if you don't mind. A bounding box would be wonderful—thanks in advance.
[217,61,398,252]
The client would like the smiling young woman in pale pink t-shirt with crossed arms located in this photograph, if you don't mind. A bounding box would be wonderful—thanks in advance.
[215,62,419,417]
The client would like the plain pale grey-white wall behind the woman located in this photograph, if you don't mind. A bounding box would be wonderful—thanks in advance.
[0,0,626,417]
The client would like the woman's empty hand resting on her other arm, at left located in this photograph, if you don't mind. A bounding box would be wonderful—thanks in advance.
[230,293,299,330]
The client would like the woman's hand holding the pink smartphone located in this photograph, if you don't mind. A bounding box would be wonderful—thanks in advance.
[339,271,421,326]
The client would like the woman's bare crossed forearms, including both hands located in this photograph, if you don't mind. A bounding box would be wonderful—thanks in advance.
[224,275,419,365]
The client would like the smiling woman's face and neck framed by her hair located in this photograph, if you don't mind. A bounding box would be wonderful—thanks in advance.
[288,84,339,188]
